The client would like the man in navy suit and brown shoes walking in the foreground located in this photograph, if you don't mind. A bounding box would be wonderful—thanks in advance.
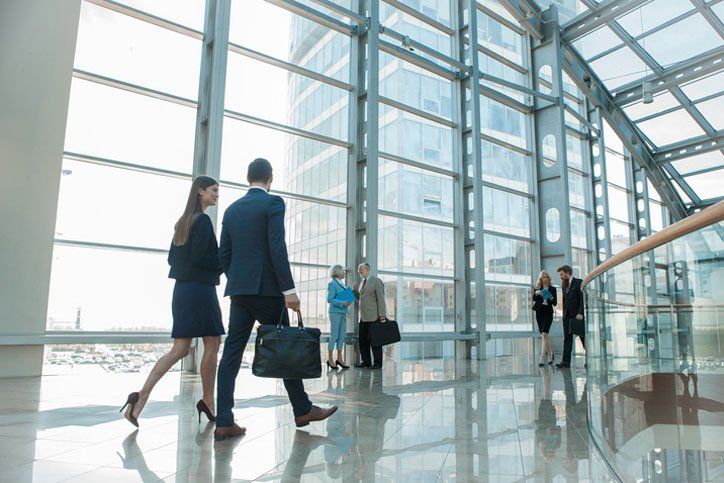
[214,158,337,440]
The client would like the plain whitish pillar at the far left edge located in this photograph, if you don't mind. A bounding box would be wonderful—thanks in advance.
[0,0,80,377]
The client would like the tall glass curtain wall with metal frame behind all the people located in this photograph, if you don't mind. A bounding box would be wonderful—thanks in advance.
[48,0,666,364]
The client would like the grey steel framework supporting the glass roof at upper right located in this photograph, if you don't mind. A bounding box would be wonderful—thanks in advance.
[501,0,724,219]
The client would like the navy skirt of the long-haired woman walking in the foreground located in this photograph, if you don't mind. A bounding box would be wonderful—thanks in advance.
[171,280,224,339]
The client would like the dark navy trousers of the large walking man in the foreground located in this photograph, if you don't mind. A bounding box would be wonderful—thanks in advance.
[216,295,312,426]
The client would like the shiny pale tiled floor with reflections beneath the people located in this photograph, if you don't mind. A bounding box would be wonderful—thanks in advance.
[0,358,611,483]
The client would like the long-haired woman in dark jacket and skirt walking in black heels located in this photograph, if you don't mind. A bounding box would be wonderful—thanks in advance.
[121,176,224,427]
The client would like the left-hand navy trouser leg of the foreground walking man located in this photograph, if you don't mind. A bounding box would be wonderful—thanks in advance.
[216,298,254,427]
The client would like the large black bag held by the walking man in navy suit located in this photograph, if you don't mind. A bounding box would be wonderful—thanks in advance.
[251,307,322,379]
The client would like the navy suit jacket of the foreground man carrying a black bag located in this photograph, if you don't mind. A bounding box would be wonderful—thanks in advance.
[219,188,294,297]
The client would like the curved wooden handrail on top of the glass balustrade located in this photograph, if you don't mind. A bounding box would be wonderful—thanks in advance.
[581,201,724,289]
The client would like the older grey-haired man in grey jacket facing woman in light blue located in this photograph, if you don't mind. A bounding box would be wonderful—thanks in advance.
[353,263,387,369]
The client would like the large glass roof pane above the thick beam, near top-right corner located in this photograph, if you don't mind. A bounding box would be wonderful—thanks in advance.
[638,14,722,67]
